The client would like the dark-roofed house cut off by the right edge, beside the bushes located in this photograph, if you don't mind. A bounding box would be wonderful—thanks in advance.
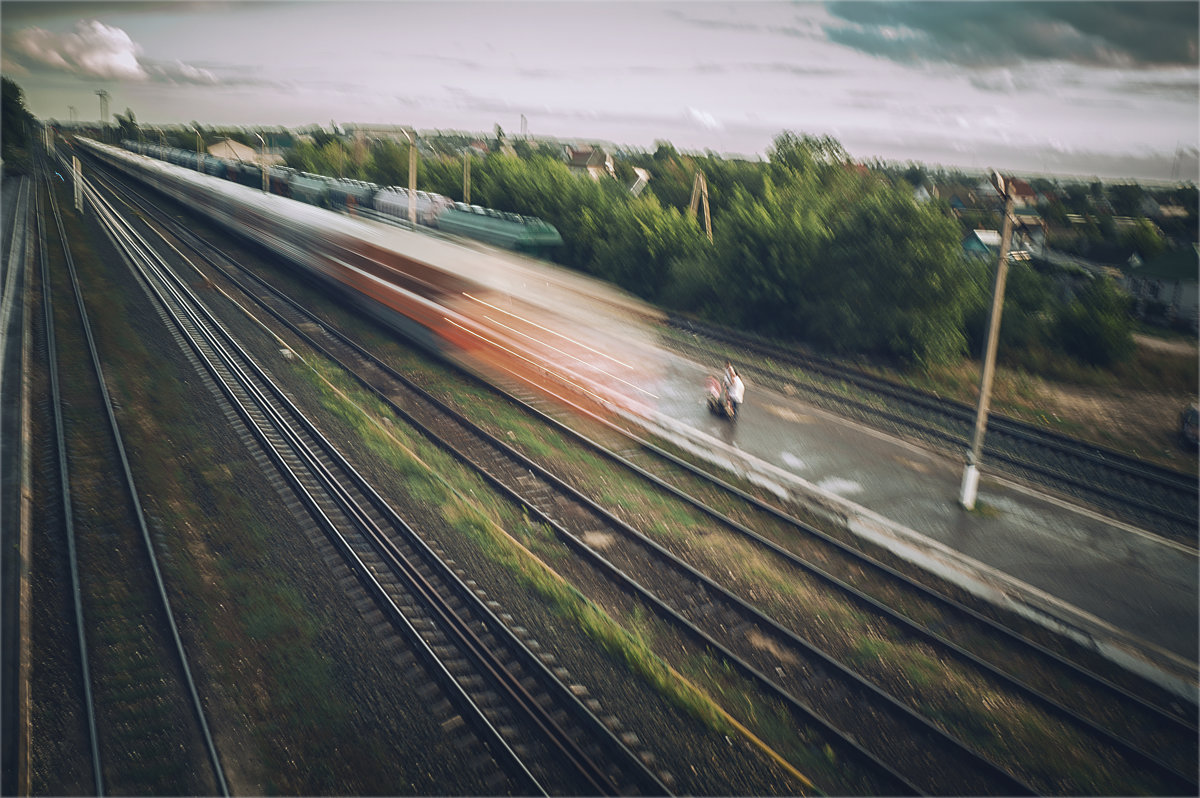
[1123,244,1200,331]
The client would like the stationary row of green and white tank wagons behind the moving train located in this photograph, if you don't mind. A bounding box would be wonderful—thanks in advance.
[121,139,563,258]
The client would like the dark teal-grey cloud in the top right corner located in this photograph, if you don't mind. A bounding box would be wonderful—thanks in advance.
[827,1,1200,68]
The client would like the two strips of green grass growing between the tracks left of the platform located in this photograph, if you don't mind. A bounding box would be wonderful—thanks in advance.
[285,314,1166,790]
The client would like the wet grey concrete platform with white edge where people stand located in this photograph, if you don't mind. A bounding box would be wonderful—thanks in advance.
[633,348,1200,702]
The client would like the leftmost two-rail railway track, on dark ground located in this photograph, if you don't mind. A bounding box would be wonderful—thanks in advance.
[32,153,229,794]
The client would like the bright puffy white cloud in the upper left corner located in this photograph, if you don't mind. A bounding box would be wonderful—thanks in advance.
[14,19,149,80]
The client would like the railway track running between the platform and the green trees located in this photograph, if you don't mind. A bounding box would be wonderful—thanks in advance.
[671,317,1200,547]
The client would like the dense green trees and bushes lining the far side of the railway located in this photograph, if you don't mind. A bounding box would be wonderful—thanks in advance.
[287,132,1133,372]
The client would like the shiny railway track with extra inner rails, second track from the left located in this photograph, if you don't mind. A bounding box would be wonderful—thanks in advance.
[78,147,670,794]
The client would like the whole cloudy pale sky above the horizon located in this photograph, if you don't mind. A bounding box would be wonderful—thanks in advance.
[0,0,1200,181]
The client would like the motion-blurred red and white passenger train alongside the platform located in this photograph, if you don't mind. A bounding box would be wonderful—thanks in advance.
[74,138,660,415]
